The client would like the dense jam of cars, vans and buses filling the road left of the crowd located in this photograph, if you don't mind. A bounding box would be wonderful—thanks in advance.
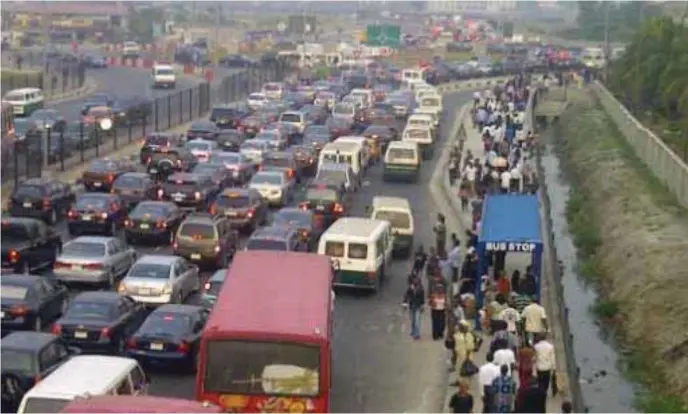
[0,60,443,413]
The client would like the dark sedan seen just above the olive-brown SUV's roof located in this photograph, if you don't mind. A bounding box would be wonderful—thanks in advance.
[158,173,220,211]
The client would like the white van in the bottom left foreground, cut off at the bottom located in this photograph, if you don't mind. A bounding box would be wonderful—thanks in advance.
[18,355,150,413]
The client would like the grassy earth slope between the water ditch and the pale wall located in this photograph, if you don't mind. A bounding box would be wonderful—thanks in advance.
[551,89,688,412]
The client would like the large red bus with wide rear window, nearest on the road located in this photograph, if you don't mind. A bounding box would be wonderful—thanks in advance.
[196,251,334,413]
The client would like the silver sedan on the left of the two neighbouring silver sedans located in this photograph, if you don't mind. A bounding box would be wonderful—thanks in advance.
[53,236,136,286]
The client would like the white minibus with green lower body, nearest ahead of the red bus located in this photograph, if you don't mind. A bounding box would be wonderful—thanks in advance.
[318,217,394,291]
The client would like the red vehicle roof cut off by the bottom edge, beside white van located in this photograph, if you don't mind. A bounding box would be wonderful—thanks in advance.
[62,395,222,413]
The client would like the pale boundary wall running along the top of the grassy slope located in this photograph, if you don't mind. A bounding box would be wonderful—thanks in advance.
[591,82,688,208]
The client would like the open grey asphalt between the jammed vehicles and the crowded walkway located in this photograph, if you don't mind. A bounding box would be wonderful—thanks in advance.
[30,88,471,412]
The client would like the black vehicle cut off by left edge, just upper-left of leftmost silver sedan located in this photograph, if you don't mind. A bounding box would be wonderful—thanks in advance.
[0,217,62,275]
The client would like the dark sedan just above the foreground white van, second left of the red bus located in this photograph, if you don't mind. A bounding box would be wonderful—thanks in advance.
[52,291,146,354]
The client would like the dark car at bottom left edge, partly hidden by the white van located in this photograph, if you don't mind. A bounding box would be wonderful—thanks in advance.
[0,331,80,398]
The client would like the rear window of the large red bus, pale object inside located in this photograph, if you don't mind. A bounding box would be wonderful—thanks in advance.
[203,341,320,397]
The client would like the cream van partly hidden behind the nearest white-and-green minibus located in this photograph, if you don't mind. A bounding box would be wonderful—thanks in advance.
[370,196,415,257]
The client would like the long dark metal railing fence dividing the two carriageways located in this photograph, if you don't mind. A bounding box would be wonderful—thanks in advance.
[2,61,287,189]
